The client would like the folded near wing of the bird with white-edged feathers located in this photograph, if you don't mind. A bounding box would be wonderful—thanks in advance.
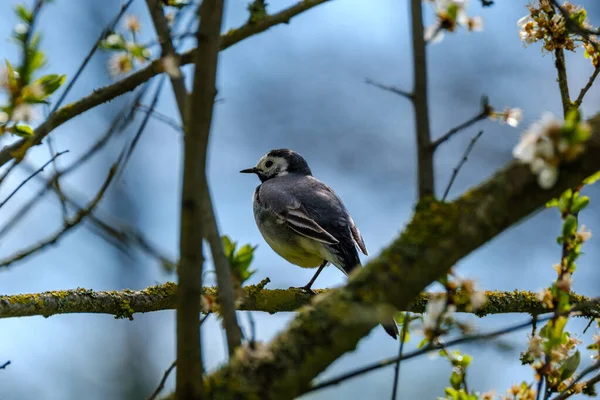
[258,182,339,245]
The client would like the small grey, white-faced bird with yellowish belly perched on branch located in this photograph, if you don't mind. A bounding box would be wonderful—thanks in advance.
[240,149,398,339]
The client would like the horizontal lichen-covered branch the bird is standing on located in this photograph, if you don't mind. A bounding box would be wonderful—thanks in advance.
[0,281,600,318]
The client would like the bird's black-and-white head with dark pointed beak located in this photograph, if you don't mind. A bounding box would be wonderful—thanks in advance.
[240,149,312,182]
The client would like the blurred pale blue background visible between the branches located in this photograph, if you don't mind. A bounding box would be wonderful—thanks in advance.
[0,0,600,400]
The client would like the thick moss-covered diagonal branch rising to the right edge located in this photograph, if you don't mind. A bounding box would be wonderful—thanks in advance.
[198,116,600,399]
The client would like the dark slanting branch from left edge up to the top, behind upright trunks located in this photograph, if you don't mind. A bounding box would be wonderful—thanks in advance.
[0,0,329,166]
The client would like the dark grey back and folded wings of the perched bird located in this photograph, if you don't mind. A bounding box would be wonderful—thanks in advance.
[260,175,368,254]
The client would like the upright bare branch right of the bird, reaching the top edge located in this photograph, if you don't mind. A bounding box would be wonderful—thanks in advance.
[411,0,435,199]
